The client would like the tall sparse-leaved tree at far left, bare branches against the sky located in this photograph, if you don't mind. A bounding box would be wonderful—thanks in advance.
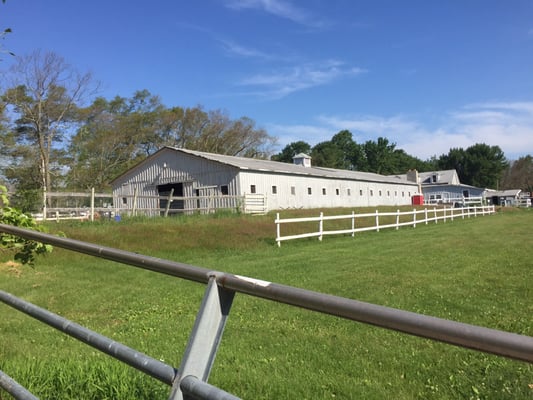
[2,51,91,209]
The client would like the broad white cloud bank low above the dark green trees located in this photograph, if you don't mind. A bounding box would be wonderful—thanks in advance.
[269,102,533,159]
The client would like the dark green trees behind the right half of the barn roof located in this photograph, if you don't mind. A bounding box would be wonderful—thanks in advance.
[272,130,516,191]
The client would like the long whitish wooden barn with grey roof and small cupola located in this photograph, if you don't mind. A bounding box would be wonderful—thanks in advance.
[111,147,418,211]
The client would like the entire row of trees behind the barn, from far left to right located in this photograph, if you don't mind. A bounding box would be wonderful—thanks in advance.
[0,51,533,210]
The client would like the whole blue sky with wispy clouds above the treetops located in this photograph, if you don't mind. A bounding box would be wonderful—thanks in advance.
[0,0,533,159]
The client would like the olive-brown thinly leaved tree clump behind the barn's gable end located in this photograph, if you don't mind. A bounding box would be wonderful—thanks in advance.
[67,90,273,190]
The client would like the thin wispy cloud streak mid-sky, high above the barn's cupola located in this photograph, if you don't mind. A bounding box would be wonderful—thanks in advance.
[239,60,367,98]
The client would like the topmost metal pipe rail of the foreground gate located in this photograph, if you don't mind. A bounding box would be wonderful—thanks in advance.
[0,224,533,363]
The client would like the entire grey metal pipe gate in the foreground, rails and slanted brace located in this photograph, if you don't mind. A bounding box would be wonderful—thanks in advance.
[0,224,533,400]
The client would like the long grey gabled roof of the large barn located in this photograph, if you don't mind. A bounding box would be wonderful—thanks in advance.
[113,146,414,185]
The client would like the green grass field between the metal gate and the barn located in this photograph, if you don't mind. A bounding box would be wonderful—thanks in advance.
[0,209,533,399]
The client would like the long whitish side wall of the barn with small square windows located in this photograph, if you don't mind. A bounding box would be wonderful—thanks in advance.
[240,171,418,210]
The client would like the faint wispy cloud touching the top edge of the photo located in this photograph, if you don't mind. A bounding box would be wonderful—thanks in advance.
[221,0,324,28]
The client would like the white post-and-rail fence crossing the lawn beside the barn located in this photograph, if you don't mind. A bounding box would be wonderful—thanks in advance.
[274,205,495,247]
